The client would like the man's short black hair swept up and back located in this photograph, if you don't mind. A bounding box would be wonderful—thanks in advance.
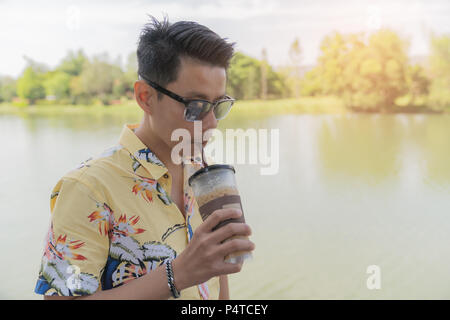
[137,16,235,99]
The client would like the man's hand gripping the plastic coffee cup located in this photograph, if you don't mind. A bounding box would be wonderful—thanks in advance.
[172,209,255,290]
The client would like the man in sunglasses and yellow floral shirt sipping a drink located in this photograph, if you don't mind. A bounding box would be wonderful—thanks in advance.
[35,18,254,299]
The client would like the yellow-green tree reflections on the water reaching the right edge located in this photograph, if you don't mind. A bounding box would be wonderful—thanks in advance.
[318,115,450,183]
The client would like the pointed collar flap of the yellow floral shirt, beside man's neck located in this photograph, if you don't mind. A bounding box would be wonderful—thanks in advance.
[119,123,168,180]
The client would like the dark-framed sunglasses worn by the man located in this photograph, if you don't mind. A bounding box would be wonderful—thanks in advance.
[139,75,235,122]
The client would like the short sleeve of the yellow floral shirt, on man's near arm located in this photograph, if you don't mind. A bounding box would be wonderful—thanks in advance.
[35,177,114,296]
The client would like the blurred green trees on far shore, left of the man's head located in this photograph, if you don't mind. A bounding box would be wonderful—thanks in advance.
[0,50,137,105]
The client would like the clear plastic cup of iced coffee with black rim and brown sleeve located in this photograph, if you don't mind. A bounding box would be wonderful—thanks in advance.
[189,164,252,263]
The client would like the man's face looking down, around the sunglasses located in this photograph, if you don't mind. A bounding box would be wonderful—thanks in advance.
[151,58,226,158]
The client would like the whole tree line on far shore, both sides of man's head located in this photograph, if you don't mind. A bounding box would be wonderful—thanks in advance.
[0,29,450,112]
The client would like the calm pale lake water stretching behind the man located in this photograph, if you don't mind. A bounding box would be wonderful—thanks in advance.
[0,110,450,299]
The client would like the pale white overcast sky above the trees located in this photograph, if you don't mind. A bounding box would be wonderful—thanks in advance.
[0,0,450,78]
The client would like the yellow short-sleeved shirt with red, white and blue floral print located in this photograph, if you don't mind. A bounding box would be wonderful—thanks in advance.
[35,124,219,299]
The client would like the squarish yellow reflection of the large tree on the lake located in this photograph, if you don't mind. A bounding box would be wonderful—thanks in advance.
[317,116,402,182]
